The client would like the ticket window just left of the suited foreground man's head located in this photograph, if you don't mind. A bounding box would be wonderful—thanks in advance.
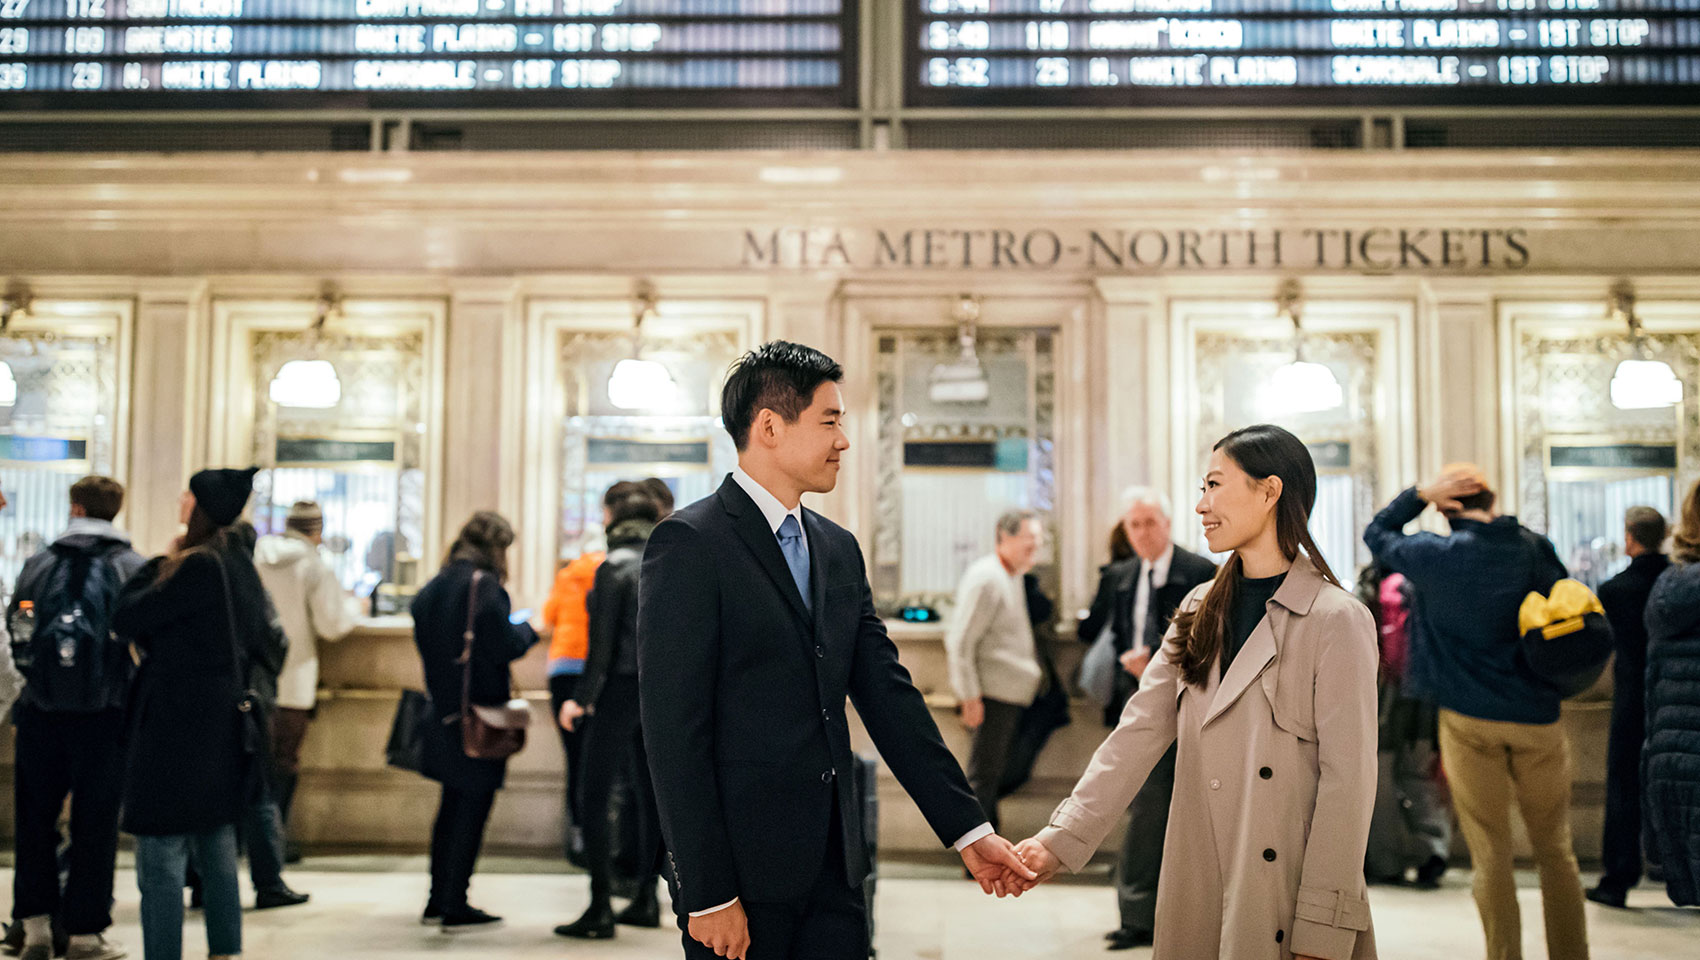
[534,309,753,586]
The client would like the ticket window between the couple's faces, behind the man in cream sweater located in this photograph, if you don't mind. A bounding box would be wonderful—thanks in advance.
[872,326,1061,615]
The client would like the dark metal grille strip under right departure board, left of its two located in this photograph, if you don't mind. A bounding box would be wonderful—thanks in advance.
[906,116,1363,150]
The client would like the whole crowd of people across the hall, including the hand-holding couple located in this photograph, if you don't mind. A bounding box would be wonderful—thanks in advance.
[0,342,1700,960]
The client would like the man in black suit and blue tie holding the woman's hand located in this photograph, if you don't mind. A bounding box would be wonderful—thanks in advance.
[638,342,1034,960]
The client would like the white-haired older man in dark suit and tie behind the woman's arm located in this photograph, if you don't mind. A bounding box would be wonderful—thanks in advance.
[1080,486,1216,950]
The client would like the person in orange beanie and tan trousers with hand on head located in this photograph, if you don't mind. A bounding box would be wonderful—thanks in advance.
[1363,464,1588,960]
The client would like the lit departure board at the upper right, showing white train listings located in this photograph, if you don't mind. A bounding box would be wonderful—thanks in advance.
[906,0,1700,107]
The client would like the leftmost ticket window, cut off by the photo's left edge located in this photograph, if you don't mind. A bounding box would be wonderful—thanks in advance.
[0,302,128,584]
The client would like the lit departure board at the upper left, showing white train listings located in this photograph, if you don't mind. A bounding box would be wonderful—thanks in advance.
[0,0,855,109]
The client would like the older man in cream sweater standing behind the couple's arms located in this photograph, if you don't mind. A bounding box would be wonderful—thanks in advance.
[945,510,1044,829]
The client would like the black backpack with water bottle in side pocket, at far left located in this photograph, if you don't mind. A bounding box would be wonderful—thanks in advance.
[9,547,133,714]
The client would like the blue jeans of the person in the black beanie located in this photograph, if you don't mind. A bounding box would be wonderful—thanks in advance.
[136,826,241,960]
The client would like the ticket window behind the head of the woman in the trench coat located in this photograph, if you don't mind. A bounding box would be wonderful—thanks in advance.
[1175,302,1411,581]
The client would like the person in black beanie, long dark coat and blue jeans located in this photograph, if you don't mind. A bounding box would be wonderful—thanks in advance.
[112,467,282,960]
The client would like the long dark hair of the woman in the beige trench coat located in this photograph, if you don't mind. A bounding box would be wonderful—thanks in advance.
[1170,423,1340,686]
